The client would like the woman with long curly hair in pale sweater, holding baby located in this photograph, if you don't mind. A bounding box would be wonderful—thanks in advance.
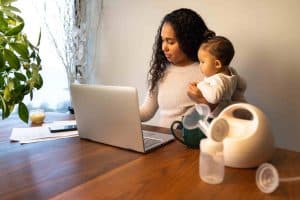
[140,8,245,128]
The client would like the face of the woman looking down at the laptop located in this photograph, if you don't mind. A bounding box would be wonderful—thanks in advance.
[161,22,193,66]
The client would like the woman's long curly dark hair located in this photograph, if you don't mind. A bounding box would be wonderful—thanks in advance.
[148,8,215,91]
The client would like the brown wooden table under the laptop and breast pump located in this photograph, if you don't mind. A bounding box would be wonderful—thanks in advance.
[0,113,300,200]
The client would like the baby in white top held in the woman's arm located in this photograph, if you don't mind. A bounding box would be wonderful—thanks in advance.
[188,36,241,117]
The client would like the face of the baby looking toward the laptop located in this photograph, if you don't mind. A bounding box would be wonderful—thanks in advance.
[198,48,218,77]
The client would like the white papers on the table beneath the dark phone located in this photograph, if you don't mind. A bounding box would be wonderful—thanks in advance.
[10,120,78,144]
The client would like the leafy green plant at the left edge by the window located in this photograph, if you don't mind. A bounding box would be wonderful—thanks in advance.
[0,0,43,123]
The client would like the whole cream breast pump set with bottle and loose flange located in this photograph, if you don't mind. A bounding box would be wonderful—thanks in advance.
[183,103,300,193]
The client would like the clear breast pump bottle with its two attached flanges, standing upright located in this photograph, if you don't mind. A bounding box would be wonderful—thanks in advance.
[183,104,229,184]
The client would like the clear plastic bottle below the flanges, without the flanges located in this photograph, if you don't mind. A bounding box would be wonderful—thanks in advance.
[199,138,225,184]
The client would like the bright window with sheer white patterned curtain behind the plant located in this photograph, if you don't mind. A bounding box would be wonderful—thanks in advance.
[14,0,103,112]
